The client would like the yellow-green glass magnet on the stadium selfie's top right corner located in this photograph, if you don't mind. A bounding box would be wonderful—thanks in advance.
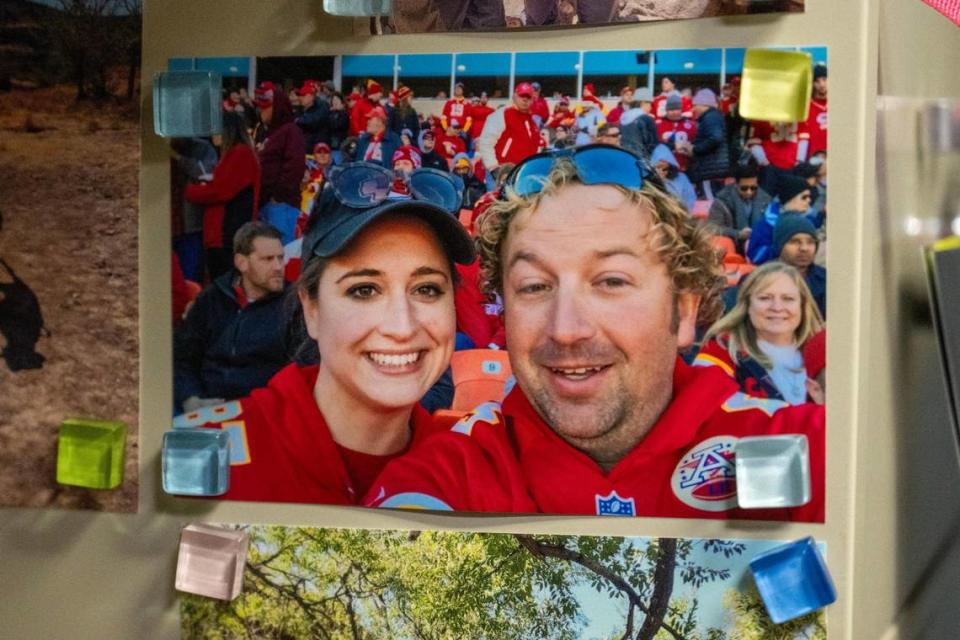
[740,49,813,122]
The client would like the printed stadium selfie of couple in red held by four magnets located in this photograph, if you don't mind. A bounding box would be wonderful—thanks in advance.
[170,48,827,522]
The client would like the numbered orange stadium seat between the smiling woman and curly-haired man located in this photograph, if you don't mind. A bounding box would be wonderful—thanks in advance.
[433,349,512,424]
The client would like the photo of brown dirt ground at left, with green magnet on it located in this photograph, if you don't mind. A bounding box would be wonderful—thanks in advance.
[0,0,141,512]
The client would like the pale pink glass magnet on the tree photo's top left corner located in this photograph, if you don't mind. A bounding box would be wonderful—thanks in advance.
[174,524,250,600]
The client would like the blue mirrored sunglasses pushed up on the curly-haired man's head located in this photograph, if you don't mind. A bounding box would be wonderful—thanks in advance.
[500,143,664,197]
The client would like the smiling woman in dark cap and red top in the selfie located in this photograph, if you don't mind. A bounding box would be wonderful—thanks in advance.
[172,163,474,504]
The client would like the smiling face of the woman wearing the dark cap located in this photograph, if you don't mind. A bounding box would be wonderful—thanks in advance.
[301,216,456,411]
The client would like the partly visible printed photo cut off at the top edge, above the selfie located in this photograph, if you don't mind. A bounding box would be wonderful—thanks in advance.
[374,0,805,34]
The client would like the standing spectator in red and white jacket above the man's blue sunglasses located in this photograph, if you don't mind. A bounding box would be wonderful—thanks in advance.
[477,82,542,171]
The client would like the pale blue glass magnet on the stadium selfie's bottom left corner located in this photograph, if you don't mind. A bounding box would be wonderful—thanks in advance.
[161,429,230,496]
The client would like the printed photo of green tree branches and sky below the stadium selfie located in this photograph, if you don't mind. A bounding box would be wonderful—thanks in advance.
[180,526,827,640]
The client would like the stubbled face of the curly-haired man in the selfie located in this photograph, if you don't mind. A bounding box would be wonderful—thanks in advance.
[500,185,699,466]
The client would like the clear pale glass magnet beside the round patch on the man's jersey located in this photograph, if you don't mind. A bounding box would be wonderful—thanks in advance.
[734,434,813,509]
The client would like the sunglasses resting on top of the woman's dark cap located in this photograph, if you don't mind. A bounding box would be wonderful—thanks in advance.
[328,162,464,213]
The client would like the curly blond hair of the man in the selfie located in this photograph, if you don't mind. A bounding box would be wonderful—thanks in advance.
[476,158,726,327]
